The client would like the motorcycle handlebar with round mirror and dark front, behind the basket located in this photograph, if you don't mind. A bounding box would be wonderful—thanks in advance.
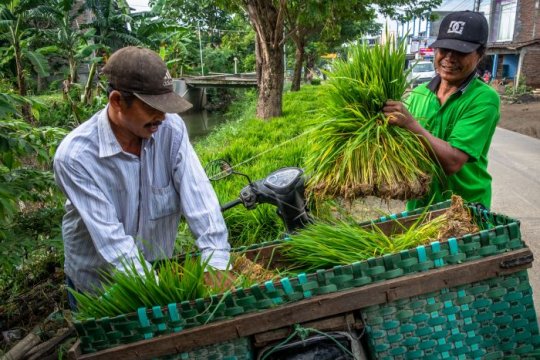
[205,159,311,234]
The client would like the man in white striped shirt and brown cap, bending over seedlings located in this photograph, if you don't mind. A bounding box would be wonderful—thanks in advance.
[54,47,230,304]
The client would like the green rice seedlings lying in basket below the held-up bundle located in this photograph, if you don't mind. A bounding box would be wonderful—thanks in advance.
[281,214,447,271]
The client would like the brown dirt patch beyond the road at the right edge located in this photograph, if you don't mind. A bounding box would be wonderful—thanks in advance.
[499,99,540,139]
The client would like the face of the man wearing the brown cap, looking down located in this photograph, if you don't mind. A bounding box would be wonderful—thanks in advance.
[119,98,165,139]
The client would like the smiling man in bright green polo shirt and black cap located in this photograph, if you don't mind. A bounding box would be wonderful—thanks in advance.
[383,11,500,209]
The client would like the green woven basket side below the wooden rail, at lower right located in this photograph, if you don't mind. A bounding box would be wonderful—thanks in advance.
[362,270,540,360]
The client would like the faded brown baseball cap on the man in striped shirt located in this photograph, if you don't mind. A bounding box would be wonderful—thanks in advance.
[102,46,193,114]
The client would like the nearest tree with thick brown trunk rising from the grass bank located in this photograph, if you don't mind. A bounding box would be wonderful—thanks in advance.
[215,0,441,119]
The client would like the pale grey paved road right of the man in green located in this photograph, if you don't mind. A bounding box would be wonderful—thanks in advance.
[488,129,540,314]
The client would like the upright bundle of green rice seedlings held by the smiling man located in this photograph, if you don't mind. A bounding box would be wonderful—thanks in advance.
[306,38,436,200]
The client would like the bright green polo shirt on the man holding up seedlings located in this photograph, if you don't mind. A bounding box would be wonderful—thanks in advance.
[406,75,500,210]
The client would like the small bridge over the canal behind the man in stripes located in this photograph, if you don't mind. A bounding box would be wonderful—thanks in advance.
[173,73,257,110]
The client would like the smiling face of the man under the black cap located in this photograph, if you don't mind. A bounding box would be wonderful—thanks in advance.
[435,48,480,86]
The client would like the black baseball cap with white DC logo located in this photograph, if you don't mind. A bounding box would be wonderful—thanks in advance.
[431,11,489,54]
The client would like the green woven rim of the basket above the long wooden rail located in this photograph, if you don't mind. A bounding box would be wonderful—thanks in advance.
[75,202,524,354]
